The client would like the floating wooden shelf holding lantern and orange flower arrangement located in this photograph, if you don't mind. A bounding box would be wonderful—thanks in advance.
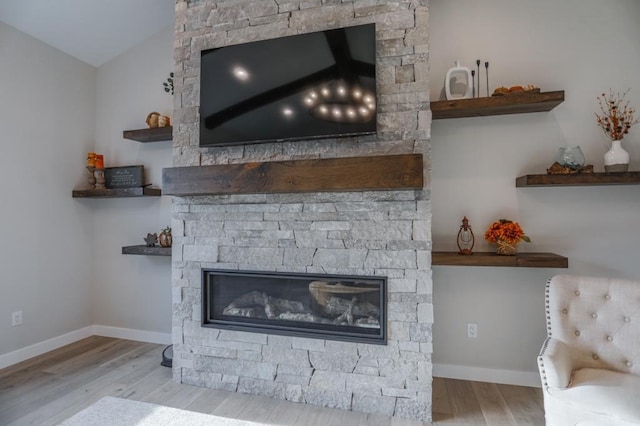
[431,251,569,268]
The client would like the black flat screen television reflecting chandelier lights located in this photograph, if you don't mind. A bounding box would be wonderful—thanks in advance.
[200,24,377,147]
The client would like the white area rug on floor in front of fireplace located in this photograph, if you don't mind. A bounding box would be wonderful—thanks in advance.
[60,396,265,426]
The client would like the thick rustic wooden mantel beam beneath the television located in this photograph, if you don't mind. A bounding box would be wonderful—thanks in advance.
[162,154,424,196]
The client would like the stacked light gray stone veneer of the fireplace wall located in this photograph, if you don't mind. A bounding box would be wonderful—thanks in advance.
[172,0,433,421]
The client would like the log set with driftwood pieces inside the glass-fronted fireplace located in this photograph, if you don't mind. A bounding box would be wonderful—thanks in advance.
[223,281,380,328]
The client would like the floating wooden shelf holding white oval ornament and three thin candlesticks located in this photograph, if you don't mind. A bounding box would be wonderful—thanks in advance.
[431,90,564,120]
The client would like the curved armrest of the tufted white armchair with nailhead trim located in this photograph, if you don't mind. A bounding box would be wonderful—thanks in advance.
[538,337,573,388]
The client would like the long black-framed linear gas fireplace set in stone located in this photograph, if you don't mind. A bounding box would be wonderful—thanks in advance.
[202,269,387,344]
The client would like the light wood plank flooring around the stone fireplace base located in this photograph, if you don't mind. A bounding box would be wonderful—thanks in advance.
[0,336,544,426]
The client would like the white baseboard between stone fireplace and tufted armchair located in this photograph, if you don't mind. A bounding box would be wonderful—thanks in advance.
[433,363,542,388]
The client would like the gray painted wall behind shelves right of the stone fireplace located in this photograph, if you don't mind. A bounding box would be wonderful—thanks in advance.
[430,0,640,385]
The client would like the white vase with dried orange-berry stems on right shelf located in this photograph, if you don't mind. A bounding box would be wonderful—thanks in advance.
[596,90,639,172]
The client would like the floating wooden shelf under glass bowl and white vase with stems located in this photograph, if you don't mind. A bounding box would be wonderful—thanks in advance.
[516,172,640,188]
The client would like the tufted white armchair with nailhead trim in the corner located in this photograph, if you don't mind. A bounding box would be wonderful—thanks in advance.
[538,275,640,426]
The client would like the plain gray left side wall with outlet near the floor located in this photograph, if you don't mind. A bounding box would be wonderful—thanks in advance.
[0,22,96,355]
